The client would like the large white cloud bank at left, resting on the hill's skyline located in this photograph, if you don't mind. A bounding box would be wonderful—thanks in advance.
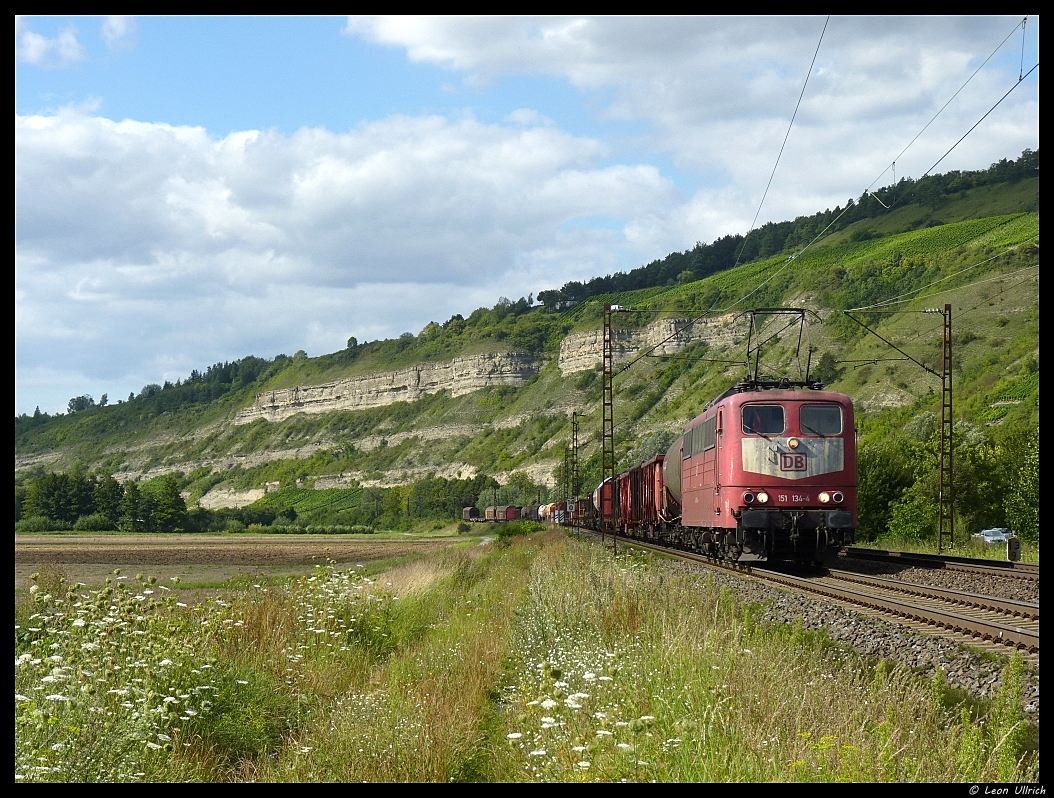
[15,109,674,410]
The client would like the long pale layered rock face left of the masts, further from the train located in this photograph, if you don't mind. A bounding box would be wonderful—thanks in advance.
[234,352,542,424]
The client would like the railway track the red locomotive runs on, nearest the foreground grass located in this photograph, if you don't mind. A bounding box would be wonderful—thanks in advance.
[579,527,1039,656]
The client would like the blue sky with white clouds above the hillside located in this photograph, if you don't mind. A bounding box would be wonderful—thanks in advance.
[15,16,1039,415]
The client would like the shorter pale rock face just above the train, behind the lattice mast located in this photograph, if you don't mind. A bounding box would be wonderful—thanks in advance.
[560,313,738,374]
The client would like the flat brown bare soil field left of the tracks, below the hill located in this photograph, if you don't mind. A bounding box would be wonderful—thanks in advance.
[15,534,458,589]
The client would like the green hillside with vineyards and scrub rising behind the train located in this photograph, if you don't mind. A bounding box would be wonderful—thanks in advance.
[15,162,1039,548]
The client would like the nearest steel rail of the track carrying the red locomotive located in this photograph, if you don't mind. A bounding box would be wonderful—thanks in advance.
[572,527,1039,654]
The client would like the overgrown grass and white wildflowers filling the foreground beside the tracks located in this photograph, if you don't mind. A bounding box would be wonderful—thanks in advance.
[16,533,1038,781]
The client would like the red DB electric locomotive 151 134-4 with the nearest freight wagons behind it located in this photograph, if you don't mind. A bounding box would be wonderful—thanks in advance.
[580,379,857,564]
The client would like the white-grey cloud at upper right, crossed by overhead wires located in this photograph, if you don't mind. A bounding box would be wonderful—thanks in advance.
[345,16,1038,231]
